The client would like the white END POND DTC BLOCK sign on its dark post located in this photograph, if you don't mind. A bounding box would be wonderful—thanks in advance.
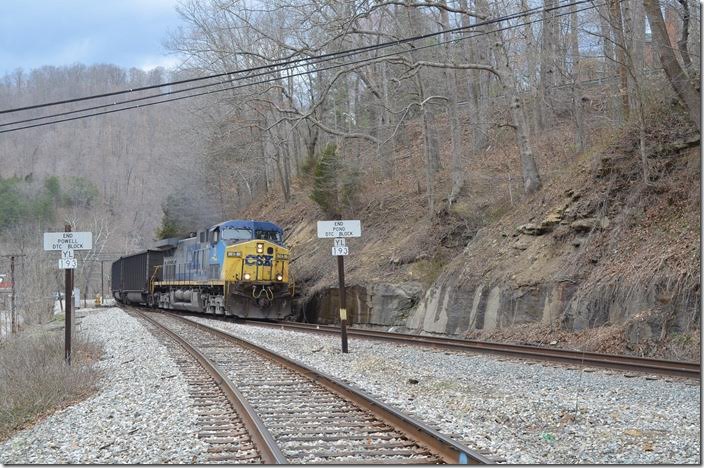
[318,220,362,353]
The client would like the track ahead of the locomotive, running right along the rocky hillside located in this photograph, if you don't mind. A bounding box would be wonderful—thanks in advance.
[230,317,701,379]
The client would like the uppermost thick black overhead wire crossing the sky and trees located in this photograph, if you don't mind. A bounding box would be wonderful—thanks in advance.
[0,0,592,119]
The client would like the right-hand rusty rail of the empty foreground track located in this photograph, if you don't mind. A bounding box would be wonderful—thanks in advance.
[171,314,494,464]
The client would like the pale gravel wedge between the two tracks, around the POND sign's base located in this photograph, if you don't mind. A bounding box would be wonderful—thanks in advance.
[190,318,701,464]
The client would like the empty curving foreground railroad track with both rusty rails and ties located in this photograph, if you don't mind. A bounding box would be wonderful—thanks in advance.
[131,312,493,464]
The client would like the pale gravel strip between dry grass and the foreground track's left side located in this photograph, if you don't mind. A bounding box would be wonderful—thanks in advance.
[0,308,205,464]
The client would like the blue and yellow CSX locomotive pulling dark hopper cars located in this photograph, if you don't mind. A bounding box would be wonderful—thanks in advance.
[112,220,291,320]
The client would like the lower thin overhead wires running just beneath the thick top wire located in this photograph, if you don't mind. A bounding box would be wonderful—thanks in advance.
[0,0,599,133]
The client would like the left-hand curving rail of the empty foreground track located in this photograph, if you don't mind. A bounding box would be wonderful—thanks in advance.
[131,308,288,465]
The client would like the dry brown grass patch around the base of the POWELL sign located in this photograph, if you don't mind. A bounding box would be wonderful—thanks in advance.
[0,333,102,441]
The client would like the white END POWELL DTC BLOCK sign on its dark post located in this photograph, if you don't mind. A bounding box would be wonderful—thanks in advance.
[44,228,93,365]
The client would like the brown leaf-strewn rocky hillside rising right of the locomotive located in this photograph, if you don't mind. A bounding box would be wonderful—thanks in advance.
[241,101,701,359]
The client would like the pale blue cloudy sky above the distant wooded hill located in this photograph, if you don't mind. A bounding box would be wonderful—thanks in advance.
[0,0,180,76]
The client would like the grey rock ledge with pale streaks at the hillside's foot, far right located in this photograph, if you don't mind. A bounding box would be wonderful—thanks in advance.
[406,275,699,343]
